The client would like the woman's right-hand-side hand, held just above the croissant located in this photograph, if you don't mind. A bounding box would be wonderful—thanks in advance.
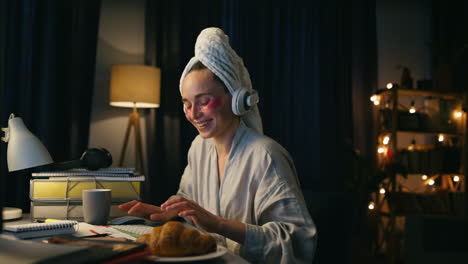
[161,196,221,233]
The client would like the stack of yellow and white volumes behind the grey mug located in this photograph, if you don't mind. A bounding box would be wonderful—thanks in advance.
[29,168,145,220]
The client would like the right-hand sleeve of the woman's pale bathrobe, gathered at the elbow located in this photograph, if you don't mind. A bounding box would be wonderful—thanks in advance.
[240,143,316,263]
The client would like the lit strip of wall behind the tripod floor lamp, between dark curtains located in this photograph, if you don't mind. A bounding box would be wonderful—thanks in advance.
[89,0,146,167]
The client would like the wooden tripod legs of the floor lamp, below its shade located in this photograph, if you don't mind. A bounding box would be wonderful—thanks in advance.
[119,104,144,174]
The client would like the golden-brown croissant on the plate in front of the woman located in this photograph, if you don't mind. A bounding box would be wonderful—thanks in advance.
[137,221,216,257]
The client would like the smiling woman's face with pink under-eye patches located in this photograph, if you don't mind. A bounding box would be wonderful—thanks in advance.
[182,69,237,138]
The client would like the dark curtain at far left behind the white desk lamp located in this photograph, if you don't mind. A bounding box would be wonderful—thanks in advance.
[0,0,100,211]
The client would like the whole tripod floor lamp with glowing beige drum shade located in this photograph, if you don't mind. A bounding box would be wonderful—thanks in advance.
[110,65,161,173]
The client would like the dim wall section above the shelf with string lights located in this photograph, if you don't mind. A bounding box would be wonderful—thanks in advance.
[376,0,432,88]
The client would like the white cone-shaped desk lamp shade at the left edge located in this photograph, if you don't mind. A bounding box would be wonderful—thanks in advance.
[3,114,54,172]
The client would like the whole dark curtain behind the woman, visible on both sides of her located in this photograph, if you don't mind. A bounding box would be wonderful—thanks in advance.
[146,0,377,263]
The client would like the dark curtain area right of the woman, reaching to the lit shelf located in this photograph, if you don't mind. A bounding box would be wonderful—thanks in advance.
[223,1,377,263]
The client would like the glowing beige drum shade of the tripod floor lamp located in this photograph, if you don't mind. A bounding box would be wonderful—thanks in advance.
[110,65,161,108]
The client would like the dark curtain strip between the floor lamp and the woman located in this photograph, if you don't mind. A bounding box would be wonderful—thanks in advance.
[143,0,222,204]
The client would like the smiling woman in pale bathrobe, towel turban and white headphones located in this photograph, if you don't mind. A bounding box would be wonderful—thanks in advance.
[120,28,316,263]
